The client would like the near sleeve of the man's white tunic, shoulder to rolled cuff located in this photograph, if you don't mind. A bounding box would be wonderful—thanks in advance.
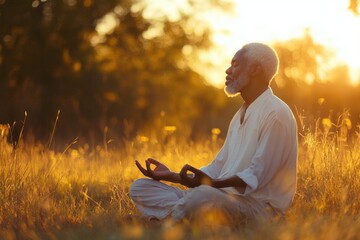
[236,110,297,208]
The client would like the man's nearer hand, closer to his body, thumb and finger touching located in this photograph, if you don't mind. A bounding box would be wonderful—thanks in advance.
[180,164,212,188]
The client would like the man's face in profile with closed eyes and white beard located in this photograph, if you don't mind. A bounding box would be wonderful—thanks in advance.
[224,50,249,97]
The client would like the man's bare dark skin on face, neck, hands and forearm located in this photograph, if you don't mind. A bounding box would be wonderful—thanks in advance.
[135,49,269,193]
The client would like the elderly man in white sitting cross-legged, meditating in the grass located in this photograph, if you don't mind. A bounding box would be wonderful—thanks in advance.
[130,43,297,220]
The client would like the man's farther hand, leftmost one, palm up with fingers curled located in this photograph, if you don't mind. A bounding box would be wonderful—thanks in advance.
[135,158,174,181]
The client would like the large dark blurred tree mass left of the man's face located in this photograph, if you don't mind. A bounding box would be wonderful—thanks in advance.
[0,0,231,145]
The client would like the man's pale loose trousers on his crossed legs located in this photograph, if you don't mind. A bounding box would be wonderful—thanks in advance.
[130,178,275,220]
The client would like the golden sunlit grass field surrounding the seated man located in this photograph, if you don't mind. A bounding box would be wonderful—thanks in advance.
[0,115,360,239]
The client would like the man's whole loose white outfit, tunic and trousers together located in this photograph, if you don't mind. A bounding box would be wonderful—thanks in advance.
[130,88,297,219]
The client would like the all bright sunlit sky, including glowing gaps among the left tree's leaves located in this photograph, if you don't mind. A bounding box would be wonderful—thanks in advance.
[97,0,360,87]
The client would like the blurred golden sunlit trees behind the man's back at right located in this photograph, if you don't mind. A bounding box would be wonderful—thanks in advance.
[273,31,360,136]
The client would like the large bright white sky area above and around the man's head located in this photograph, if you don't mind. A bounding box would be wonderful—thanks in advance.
[204,0,360,86]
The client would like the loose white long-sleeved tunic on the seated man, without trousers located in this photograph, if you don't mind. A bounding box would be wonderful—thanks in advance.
[201,88,298,212]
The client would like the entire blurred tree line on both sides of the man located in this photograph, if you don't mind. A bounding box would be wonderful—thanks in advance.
[0,0,360,147]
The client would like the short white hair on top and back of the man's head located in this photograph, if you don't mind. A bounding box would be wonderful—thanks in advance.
[240,43,279,83]
